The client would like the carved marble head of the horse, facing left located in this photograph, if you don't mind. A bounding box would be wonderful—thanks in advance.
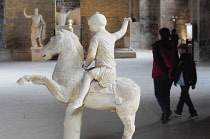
[42,31,64,60]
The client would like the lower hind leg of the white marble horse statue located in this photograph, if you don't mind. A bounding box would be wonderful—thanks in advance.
[117,112,136,139]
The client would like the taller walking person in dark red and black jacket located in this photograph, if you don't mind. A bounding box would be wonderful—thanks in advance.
[152,28,178,124]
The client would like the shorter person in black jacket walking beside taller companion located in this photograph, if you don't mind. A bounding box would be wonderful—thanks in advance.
[174,44,198,120]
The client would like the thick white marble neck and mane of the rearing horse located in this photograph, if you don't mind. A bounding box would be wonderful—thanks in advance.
[52,30,84,89]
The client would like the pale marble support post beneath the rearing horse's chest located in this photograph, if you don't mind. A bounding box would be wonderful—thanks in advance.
[63,103,83,139]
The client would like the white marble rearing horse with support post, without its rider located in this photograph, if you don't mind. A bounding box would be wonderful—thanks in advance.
[17,26,140,139]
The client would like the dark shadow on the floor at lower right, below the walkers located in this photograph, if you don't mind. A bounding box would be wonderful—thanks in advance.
[133,116,210,139]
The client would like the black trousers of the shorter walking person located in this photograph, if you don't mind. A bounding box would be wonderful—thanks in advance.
[176,86,197,115]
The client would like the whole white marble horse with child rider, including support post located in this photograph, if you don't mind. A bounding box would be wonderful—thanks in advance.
[17,13,140,139]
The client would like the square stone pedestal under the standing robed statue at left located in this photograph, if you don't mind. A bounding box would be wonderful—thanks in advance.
[31,47,44,61]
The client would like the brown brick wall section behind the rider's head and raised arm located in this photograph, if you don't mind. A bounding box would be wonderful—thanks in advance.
[80,0,130,48]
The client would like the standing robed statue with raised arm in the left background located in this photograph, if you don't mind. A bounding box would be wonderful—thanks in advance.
[24,8,46,47]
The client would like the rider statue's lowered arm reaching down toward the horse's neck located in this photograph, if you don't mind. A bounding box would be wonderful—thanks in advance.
[84,38,98,67]
